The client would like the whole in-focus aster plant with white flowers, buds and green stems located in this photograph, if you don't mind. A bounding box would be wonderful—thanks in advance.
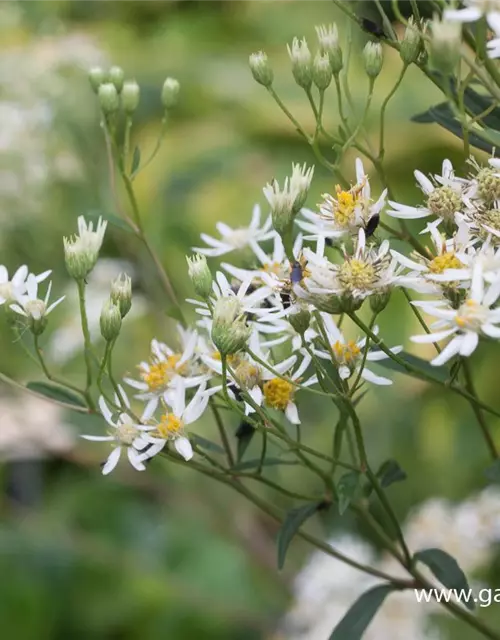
[4,0,500,640]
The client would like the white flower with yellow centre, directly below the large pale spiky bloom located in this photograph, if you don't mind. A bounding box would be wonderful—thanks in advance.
[313,313,403,385]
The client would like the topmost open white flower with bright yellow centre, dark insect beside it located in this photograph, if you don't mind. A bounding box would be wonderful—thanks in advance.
[297,158,387,238]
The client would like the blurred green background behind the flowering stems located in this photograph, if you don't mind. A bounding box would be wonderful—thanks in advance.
[0,0,500,640]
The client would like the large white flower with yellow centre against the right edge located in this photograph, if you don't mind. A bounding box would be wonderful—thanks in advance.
[411,264,500,366]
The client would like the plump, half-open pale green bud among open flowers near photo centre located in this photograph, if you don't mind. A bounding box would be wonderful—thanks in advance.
[212,296,251,357]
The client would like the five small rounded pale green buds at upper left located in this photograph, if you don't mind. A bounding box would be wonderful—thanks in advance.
[89,66,180,118]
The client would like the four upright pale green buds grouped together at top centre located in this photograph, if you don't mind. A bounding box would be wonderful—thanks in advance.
[249,24,343,91]
